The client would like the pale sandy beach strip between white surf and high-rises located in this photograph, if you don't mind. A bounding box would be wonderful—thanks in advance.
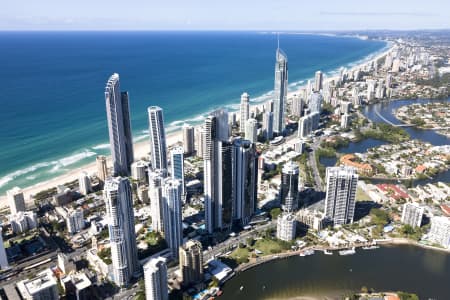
[0,43,392,208]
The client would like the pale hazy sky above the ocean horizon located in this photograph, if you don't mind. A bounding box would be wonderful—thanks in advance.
[0,0,450,30]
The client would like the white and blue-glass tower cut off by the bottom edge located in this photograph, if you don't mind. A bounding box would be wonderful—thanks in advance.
[144,256,169,300]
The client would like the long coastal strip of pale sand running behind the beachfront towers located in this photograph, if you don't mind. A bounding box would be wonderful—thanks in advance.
[0,43,394,209]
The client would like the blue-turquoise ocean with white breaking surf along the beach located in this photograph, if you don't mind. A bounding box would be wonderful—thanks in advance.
[0,32,386,195]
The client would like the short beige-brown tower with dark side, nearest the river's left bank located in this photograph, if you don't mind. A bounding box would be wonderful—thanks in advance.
[180,240,203,286]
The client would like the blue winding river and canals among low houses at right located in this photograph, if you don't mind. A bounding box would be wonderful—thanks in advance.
[320,98,450,186]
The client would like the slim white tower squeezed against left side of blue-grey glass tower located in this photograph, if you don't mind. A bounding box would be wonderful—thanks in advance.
[148,170,164,233]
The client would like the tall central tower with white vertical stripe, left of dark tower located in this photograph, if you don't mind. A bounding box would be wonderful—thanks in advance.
[203,110,233,233]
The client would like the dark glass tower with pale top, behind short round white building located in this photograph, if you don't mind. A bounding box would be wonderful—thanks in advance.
[280,161,299,212]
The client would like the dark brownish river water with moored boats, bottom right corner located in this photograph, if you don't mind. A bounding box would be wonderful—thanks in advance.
[221,246,450,300]
